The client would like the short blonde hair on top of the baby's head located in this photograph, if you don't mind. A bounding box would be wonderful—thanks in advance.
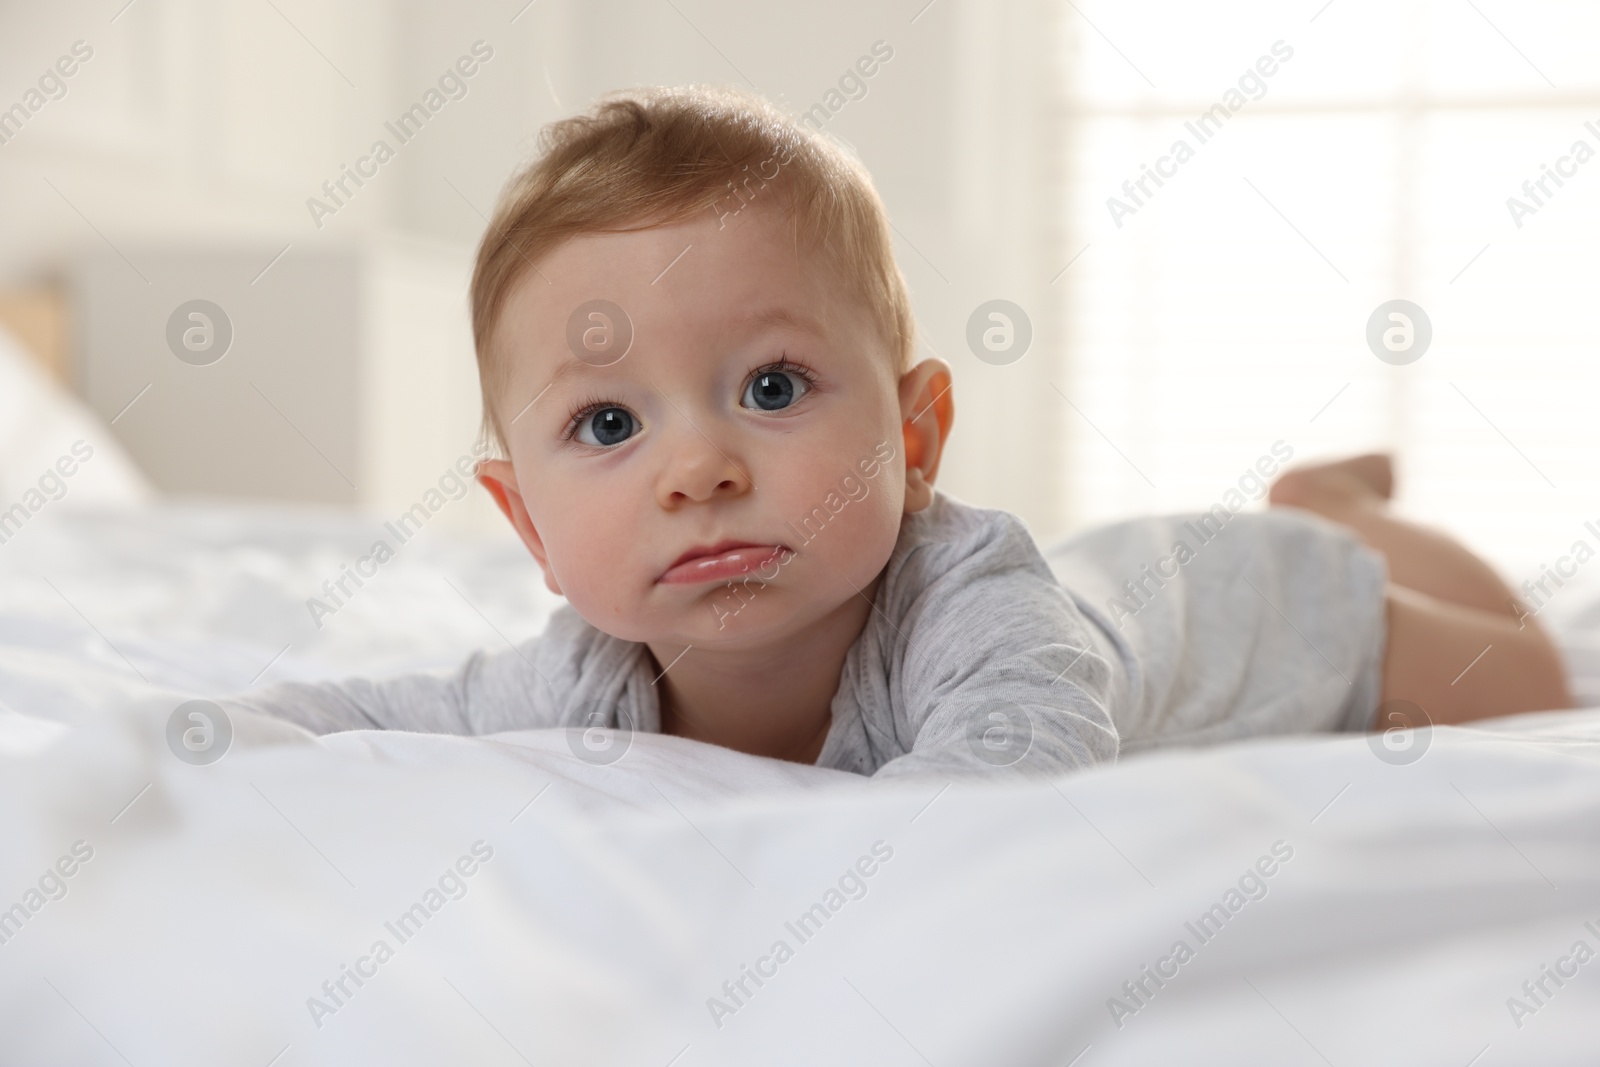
[472,86,915,454]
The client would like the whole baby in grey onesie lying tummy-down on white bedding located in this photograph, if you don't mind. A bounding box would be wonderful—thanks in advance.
[235,88,1568,776]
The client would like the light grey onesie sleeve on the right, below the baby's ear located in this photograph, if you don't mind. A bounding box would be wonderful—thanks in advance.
[875,510,1117,777]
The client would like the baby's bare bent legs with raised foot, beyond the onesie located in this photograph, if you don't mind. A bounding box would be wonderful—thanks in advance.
[1270,456,1571,723]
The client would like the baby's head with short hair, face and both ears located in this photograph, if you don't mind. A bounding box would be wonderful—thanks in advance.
[472,88,954,649]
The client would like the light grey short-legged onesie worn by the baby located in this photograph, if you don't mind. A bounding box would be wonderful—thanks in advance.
[226,493,1384,776]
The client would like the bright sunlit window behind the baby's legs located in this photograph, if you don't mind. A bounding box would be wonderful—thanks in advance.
[1056,0,1600,584]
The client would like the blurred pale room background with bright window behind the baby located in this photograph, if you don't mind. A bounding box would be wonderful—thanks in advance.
[0,0,1600,584]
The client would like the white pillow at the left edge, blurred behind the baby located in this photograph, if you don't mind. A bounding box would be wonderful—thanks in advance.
[0,326,155,514]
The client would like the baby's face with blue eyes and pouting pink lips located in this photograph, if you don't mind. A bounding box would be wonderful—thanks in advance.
[483,208,931,649]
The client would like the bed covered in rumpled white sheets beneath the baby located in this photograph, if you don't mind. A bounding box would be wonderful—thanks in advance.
[9,321,1600,1067]
